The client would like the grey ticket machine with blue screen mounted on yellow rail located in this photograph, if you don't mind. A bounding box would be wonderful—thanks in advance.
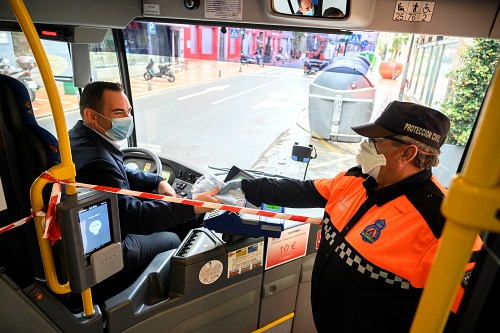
[57,191,123,292]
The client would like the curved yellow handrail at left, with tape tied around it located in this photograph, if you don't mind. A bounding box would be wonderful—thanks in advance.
[9,0,94,316]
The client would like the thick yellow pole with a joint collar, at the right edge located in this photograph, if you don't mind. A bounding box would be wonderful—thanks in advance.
[411,57,500,333]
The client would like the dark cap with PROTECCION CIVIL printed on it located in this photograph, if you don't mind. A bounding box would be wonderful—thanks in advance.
[351,101,450,148]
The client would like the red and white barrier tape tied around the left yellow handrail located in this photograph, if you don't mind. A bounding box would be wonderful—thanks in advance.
[0,172,323,238]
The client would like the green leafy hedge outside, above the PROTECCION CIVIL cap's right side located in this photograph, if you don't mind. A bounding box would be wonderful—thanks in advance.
[441,39,500,146]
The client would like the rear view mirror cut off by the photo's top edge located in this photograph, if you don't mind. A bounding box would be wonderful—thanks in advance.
[272,0,350,20]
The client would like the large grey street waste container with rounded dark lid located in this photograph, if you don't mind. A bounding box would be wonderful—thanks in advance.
[309,55,376,142]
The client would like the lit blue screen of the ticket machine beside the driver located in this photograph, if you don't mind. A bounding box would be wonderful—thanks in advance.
[78,200,111,255]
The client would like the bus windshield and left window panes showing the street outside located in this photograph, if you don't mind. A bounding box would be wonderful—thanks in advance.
[11,22,499,186]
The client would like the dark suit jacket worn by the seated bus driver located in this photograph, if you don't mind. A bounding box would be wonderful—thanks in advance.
[69,120,195,238]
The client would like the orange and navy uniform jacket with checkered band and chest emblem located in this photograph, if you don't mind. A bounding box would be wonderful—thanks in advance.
[242,166,482,332]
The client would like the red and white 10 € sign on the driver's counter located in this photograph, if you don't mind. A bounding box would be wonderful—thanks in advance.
[265,220,311,269]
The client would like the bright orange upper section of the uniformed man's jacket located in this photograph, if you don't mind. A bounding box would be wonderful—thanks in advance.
[314,173,482,288]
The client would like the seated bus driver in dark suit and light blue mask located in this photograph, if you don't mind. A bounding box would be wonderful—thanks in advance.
[69,81,216,275]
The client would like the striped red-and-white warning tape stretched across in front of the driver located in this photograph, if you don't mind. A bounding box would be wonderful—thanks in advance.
[0,172,323,234]
